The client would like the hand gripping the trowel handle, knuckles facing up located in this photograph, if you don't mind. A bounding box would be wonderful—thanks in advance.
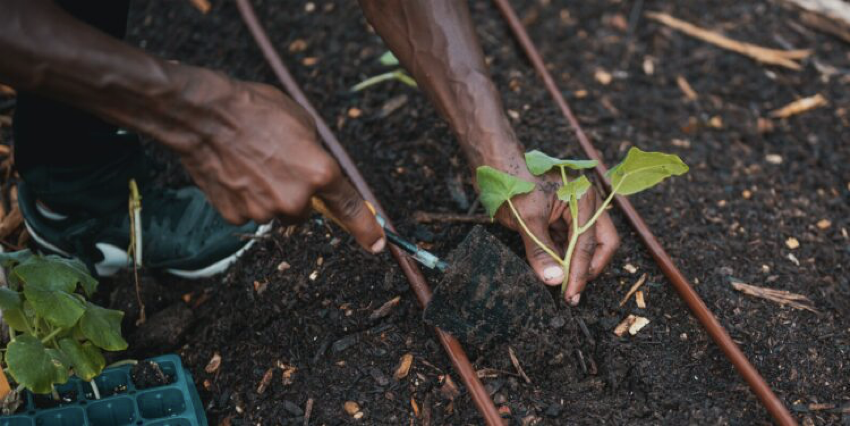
[176,80,386,253]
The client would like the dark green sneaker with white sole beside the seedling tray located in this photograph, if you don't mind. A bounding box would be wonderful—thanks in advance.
[18,182,271,279]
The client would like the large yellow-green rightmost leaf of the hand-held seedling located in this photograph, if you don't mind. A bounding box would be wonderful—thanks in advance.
[607,148,688,195]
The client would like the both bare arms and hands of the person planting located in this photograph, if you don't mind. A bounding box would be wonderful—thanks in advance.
[0,0,619,304]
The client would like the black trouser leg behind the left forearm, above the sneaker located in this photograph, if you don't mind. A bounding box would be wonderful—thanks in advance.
[14,0,144,215]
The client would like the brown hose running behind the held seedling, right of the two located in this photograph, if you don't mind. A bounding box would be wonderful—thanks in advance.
[493,0,797,425]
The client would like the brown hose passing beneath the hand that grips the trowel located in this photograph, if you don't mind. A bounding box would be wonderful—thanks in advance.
[236,0,503,426]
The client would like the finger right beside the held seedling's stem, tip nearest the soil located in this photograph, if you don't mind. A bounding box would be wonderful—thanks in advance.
[564,191,596,306]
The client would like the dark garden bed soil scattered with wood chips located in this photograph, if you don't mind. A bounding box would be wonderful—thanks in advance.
[16,0,850,425]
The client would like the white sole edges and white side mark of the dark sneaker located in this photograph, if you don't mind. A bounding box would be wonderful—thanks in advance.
[24,220,272,279]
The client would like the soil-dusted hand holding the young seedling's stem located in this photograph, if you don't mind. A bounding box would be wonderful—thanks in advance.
[496,164,620,306]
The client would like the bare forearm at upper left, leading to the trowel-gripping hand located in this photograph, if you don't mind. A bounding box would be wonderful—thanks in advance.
[0,0,226,153]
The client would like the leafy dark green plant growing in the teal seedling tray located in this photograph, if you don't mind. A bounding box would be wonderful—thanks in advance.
[0,250,127,395]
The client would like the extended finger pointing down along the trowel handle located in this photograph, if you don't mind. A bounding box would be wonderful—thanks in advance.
[317,174,386,253]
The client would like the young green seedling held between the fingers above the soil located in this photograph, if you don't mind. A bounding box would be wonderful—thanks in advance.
[477,148,688,294]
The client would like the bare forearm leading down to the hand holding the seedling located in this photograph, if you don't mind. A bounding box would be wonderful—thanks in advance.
[360,0,522,169]
